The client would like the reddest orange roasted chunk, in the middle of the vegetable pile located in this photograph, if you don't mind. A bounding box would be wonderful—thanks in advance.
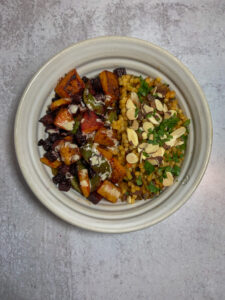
[81,111,103,133]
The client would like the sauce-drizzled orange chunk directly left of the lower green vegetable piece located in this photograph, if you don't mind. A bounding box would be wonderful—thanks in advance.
[59,141,81,166]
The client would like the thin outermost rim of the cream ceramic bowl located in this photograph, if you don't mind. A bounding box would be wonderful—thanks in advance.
[14,36,213,233]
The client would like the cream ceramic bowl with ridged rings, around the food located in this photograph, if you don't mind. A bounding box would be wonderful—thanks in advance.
[15,37,212,232]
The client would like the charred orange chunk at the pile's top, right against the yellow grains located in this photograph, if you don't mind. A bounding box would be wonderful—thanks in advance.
[99,71,120,106]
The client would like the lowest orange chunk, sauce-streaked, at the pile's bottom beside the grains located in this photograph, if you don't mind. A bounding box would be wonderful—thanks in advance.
[97,180,121,203]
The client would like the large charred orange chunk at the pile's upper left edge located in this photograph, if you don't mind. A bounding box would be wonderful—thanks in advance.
[55,69,85,98]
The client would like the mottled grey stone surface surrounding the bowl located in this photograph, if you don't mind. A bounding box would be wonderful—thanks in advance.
[0,0,225,300]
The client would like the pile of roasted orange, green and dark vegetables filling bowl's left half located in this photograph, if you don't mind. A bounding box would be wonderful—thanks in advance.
[38,68,126,204]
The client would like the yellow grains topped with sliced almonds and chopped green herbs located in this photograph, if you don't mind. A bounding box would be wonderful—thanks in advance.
[112,74,190,203]
